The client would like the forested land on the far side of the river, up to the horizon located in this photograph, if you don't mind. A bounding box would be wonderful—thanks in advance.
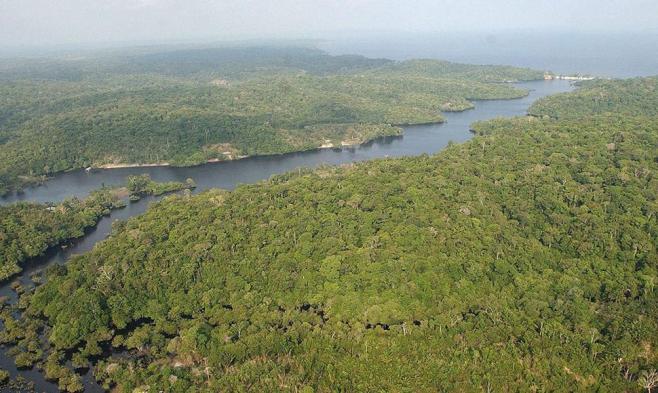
[0,48,542,193]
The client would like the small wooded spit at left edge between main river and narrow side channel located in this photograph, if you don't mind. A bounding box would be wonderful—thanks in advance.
[0,188,122,281]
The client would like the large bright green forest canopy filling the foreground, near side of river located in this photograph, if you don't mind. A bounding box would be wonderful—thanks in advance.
[2,77,658,392]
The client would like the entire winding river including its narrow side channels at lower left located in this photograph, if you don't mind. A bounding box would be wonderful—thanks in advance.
[0,81,572,392]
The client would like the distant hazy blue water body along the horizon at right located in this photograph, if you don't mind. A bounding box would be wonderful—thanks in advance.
[318,32,658,78]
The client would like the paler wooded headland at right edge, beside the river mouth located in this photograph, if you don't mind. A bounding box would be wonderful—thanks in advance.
[528,77,658,119]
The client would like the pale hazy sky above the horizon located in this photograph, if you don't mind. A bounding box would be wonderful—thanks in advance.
[0,0,658,47]
